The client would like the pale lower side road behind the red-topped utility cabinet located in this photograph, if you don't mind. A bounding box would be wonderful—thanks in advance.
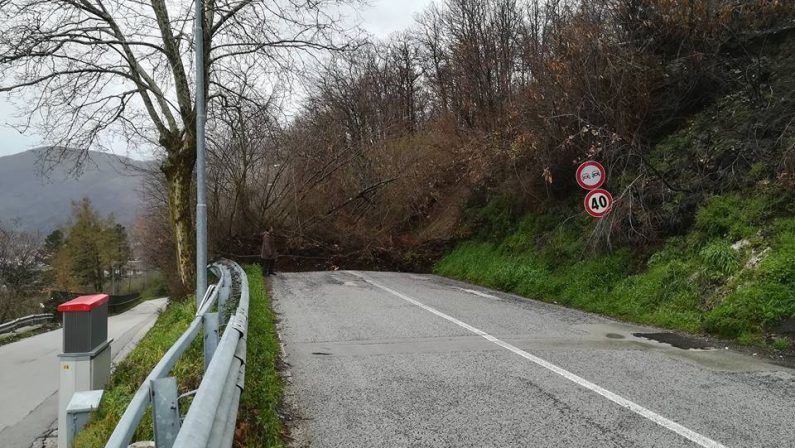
[0,299,166,448]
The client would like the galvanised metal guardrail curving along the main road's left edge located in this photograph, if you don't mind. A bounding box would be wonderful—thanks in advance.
[105,261,249,448]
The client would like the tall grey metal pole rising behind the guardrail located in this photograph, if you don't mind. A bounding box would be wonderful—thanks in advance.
[193,0,207,306]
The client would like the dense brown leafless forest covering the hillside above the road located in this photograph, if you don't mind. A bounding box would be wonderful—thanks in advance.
[127,0,795,292]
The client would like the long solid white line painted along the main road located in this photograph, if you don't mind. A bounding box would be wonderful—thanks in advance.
[351,272,726,448]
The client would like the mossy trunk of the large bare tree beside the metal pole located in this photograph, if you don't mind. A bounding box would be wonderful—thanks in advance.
[160,133,196,293]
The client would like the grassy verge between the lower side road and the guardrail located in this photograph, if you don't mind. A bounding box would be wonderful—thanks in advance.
[74,300,203,448]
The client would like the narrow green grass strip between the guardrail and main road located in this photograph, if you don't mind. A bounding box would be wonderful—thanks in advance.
[238,265,284,448]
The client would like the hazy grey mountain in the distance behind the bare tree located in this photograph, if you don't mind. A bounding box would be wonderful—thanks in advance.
[0,148,153,235]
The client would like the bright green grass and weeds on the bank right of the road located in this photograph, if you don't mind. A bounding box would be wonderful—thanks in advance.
[435,189,795,349]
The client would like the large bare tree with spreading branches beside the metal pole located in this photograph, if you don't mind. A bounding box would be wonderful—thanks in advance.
[0,0,357,292]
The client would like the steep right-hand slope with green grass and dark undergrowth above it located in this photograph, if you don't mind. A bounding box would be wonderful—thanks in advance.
[435,27,795,351]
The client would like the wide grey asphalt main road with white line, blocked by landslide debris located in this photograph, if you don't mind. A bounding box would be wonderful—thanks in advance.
[273,272,795,448]
